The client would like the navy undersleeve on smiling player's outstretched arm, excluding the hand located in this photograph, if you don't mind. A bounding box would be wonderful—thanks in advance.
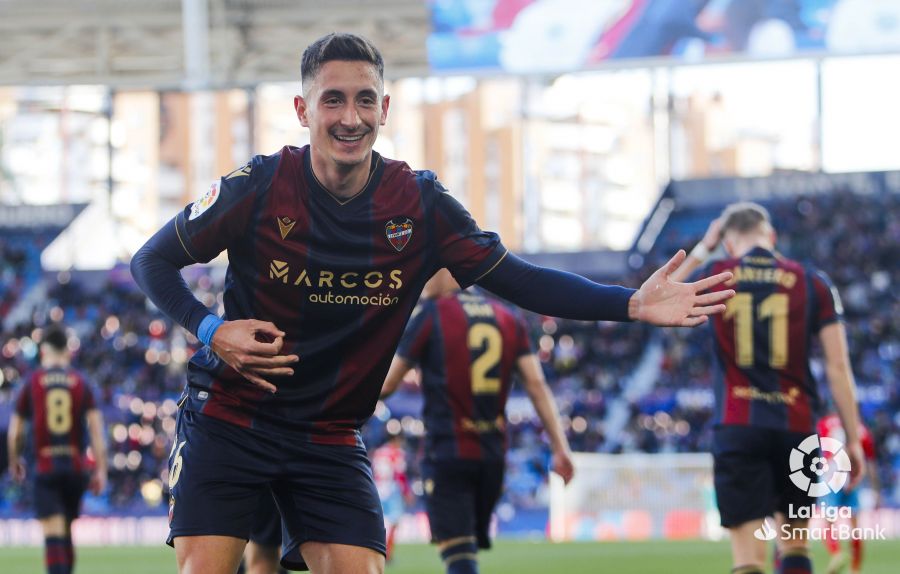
[478,253,635,321]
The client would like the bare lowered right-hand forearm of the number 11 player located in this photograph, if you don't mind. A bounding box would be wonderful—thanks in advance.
[819,322,866,488]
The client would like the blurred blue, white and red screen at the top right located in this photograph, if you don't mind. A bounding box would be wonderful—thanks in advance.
[428,0,900,74]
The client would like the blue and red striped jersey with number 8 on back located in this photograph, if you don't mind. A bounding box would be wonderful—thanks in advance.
[15,368,97,474]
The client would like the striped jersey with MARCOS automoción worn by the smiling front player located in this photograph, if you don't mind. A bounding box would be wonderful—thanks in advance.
[176,146,506,444]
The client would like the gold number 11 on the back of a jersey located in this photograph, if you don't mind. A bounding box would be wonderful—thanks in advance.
[723,293,789,369]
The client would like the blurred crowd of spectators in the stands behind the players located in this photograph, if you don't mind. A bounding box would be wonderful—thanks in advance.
[0,190,900,528]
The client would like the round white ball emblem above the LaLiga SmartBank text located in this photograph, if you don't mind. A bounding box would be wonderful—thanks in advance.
[788,434,850,498]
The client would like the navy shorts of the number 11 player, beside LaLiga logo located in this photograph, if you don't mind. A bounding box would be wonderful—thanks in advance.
[713,425,815,528]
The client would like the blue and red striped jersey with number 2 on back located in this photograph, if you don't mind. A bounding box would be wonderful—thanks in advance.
[397,291,533,460]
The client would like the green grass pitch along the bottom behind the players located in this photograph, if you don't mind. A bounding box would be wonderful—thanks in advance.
[0,541,900,574]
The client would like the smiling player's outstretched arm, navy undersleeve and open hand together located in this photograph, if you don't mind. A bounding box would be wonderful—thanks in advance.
[478,251,734,326]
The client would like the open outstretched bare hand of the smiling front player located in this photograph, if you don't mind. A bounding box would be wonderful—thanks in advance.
[628,249,734,327]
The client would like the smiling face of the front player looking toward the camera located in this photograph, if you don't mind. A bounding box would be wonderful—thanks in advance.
[294,60,390,170]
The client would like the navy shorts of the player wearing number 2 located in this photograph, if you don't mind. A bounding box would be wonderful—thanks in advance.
[422,459,504,549]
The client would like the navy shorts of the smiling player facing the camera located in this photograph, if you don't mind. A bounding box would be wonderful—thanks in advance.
[167,410,385,570]
